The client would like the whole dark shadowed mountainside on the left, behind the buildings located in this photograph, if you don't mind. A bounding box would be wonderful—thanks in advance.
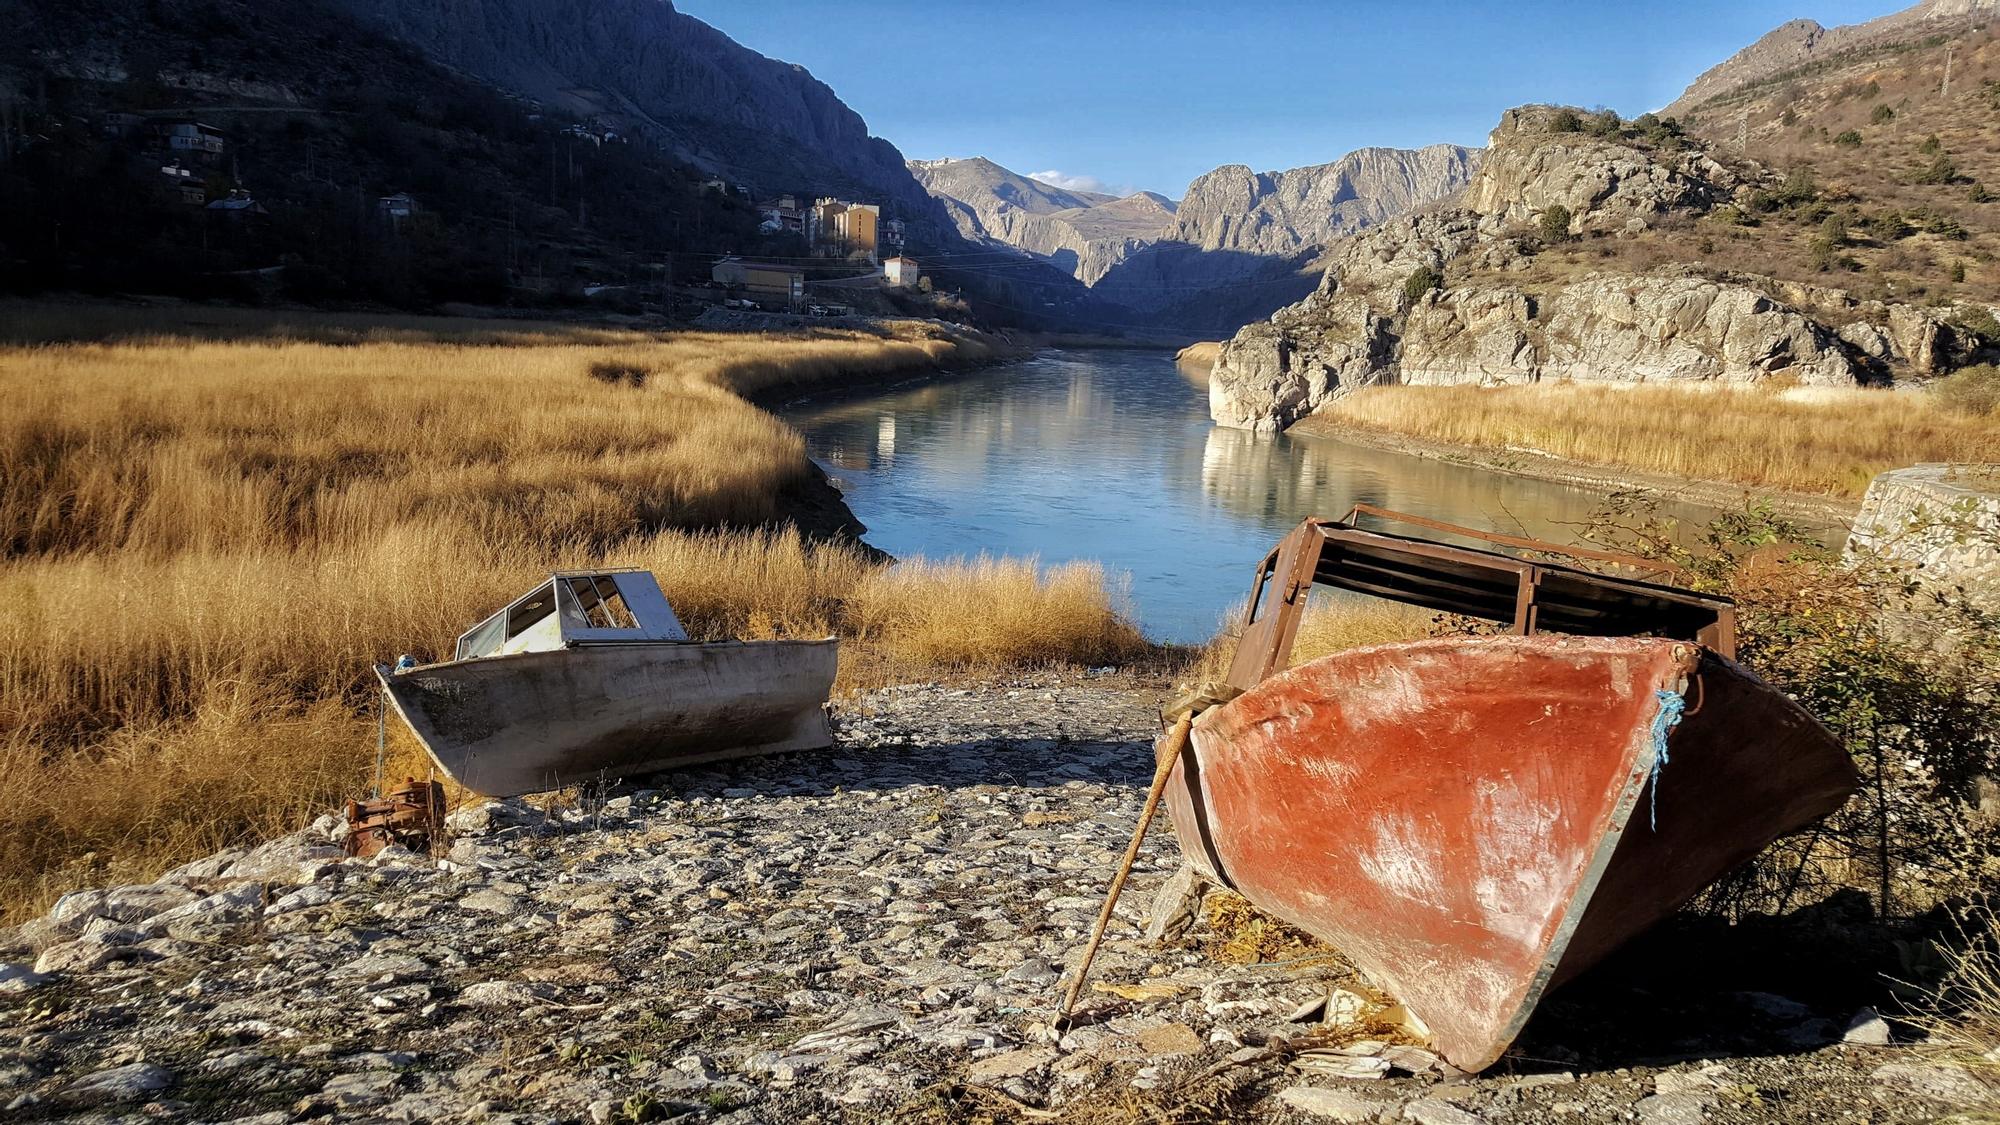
[0,0,1130,328]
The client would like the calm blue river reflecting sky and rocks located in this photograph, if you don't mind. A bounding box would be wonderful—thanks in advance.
[786,350,1700,643]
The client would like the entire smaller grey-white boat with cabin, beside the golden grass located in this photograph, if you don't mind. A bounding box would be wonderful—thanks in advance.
[376,571,836,797]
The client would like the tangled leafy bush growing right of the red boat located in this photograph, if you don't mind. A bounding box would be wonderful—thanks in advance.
[1584,496,2000,915]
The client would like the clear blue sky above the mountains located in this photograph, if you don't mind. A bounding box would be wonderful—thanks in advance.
[674,0,1906,198]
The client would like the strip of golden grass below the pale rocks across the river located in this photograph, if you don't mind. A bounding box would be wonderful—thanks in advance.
[1318,384,2000,496]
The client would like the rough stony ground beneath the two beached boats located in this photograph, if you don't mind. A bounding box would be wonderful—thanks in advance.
[0,677,1992,1125]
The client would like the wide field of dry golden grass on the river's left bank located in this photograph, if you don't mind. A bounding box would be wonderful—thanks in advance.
[0,312,1144,917]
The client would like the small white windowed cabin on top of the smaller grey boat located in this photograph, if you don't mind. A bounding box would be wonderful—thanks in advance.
[454,571,688,661]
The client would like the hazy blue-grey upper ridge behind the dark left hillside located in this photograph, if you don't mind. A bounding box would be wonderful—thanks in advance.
[330,0,942,212]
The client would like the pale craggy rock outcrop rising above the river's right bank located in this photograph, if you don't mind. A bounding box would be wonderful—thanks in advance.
[1210,106,1992,430]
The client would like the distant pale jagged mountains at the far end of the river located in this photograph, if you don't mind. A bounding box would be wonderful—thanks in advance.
[912,144,1478,332]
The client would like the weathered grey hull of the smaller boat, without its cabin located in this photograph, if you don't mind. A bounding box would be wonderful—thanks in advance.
[382,641,836,797]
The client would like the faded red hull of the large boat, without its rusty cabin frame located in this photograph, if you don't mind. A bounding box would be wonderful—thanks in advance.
[1168,635,1856,1071]
